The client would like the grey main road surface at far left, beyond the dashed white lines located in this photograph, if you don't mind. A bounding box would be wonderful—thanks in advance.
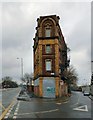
[0,88,20,118]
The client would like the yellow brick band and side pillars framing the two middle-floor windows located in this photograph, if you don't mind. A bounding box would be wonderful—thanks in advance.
[34,39,58,77]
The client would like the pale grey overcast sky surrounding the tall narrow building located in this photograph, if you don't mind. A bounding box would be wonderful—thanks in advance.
[0,0,91,85]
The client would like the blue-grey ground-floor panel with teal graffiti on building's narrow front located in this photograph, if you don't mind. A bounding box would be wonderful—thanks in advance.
[43,77,55,98]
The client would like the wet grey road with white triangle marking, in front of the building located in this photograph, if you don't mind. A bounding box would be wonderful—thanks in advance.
[2,92,93,118]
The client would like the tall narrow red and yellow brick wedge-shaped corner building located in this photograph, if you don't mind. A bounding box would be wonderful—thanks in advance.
[33,15,67,98]
